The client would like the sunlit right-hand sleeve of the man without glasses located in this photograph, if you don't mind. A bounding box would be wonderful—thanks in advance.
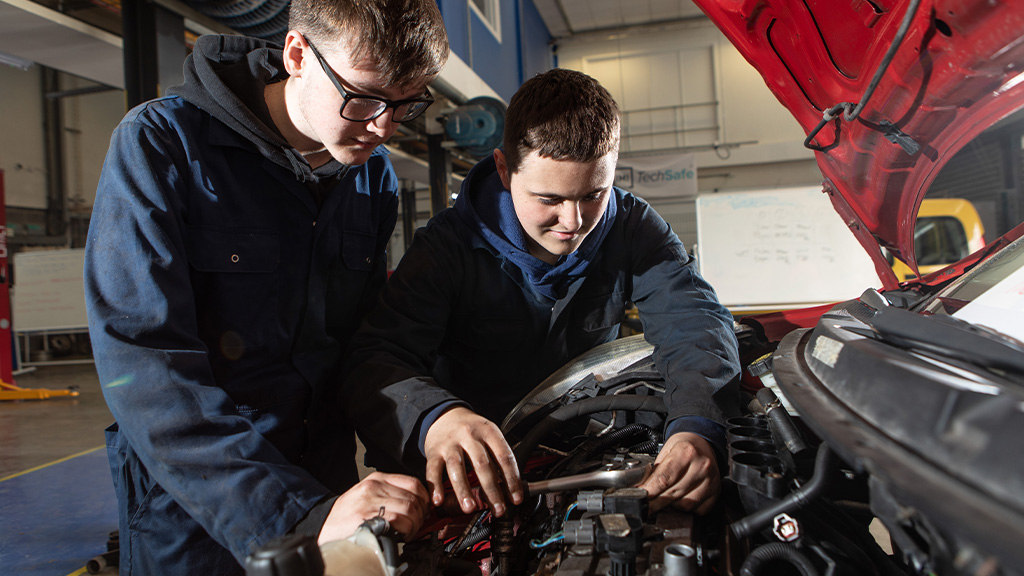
[627,200,739,426]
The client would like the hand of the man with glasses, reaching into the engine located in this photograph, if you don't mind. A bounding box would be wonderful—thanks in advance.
[317,472,430,544]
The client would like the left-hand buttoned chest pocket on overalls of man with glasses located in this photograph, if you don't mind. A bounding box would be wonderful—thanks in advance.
[186,228,281,356]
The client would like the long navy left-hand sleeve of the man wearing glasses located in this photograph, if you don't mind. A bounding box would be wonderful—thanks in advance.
[85,118,328,562]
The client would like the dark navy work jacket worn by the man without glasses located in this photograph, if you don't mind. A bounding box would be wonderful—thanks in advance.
[346,183,739,470]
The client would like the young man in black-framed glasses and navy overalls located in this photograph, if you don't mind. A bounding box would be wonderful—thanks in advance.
[85,0,447,576]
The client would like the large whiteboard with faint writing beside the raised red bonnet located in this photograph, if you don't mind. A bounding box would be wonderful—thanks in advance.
[696,188,882,307]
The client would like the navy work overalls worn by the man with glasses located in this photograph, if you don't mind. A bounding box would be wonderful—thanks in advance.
[85,97,397,574]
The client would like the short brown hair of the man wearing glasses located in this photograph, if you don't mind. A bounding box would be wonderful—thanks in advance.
[288,0,449,87]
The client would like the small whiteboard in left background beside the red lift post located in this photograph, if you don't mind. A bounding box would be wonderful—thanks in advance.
[11,249,89,332]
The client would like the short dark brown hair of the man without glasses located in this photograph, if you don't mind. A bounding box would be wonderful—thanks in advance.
[504,68,620,175]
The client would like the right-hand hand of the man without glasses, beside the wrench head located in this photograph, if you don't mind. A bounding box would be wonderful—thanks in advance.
[640,433,721,515]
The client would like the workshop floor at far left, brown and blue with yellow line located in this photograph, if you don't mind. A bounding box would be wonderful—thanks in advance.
[0,364,117,576]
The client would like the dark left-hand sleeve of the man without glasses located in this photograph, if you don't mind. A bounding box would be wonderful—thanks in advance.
[345,214,465,474]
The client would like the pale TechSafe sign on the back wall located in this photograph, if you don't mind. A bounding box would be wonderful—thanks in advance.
[615,154,697,198]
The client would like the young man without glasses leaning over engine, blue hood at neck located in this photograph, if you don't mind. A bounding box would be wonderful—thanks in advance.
[346,70,739,517]
